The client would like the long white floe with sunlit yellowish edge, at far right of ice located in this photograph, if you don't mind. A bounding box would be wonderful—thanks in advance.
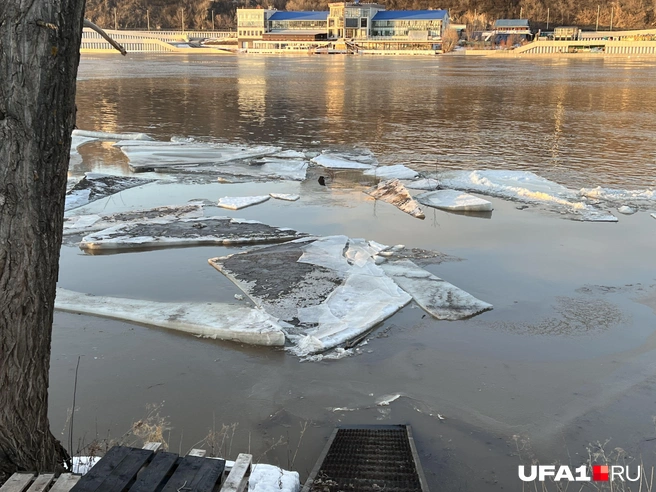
[436,170,617,222]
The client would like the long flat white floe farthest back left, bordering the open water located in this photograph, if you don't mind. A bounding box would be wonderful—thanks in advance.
[115,140,280,171]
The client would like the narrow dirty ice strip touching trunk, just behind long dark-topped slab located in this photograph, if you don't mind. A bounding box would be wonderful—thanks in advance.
[64,204,203,235]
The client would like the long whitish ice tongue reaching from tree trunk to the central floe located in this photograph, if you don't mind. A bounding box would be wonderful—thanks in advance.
[55,289,285,346]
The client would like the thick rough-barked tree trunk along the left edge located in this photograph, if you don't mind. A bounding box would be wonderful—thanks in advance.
[0,0,84,473]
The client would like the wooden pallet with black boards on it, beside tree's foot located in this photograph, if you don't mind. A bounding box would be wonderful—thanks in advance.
[0,443,252,492]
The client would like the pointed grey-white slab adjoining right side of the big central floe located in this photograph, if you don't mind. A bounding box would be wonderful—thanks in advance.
[381,260,492,320]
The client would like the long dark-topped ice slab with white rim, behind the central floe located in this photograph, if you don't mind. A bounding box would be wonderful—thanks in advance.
[80,217,304,250]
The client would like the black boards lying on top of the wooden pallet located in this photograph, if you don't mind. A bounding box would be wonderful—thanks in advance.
[71,446,225,492]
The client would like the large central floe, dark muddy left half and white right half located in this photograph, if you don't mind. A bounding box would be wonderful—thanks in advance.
[210,236,411,356]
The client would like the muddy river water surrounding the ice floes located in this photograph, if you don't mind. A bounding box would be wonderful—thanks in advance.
[50,55,656,491]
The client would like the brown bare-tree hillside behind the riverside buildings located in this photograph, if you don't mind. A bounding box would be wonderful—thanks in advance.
[86,0,656,30]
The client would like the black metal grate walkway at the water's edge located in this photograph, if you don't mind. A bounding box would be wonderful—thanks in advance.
[303,425,428,492]
